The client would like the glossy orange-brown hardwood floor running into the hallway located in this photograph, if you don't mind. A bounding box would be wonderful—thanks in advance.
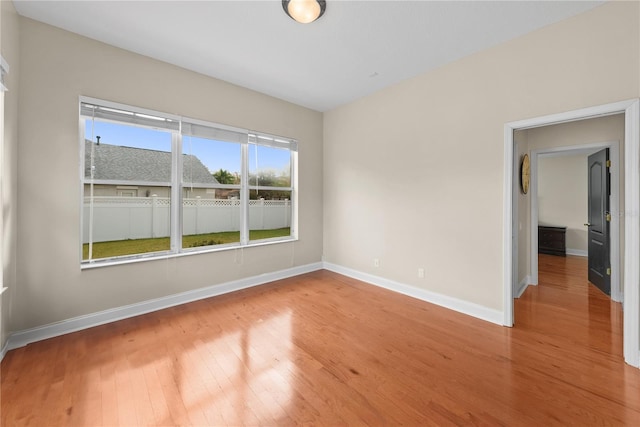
[1,256,640,426]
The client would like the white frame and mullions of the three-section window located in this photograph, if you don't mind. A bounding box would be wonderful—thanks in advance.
[78,96,298,269]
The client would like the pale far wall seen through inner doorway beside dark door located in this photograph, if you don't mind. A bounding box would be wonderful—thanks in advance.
[538,154,588,252]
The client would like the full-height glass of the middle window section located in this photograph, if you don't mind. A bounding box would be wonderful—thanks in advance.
[182,136,242,248]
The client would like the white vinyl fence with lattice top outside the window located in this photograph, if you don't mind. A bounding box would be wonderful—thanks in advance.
[82,197,291,243]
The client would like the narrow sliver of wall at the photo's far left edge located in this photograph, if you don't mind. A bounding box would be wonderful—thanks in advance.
[0,0,20,349]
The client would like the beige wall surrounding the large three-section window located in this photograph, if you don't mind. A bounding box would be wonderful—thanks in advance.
[11,18,322,331]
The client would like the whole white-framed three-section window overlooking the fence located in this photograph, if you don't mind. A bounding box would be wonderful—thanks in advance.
[80,97,297,265]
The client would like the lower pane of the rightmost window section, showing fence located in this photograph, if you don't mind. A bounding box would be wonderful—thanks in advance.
[249,190,292,240]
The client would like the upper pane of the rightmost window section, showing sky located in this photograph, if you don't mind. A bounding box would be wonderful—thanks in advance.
[249,144,291,187]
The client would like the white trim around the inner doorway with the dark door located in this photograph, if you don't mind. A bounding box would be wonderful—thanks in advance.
[530,141,622,302]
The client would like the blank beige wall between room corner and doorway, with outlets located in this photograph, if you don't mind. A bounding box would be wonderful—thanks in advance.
[324,2,640,310]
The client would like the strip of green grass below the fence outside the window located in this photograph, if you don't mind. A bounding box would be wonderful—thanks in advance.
[82,227,291,259]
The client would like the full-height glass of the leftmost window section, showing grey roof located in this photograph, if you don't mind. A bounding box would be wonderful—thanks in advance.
[82,119,172,260]
